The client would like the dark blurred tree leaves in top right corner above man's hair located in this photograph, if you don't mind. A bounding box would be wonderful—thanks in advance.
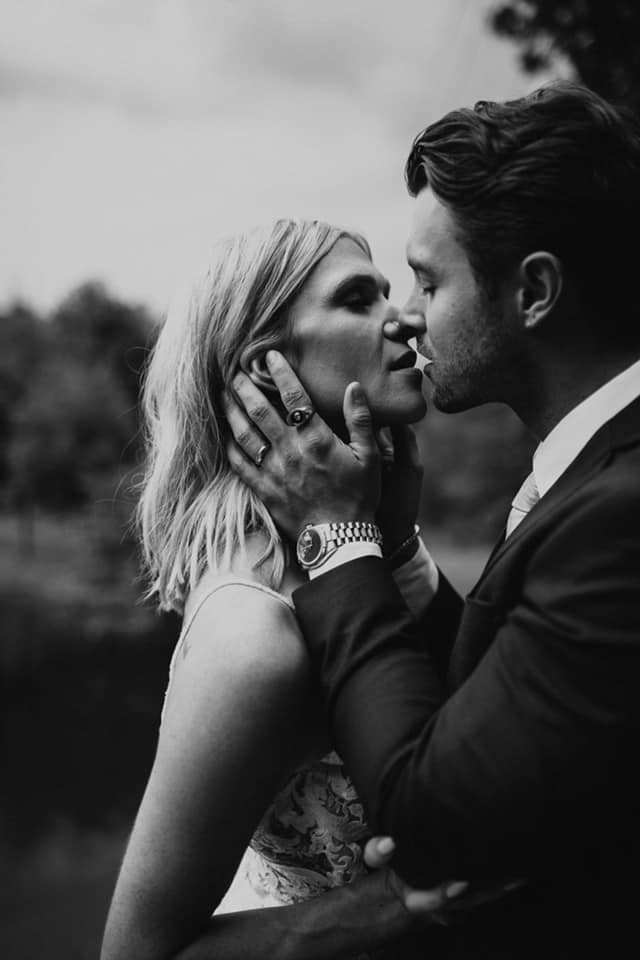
[490,0,640,113]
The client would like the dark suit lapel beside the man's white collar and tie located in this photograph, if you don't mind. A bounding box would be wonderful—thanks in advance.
[472,397,640,592]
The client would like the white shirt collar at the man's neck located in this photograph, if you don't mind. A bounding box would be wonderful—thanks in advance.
[533,360,640,497]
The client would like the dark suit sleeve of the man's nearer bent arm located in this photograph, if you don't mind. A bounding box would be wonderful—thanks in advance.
[294,489,640,886]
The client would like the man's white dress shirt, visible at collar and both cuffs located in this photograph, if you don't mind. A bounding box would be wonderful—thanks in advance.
[309,360,640,617]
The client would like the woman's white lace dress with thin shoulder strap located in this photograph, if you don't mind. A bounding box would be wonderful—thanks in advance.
[162,578,370,913]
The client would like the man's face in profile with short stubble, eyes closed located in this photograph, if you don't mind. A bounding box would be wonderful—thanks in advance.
[405,188,515,413]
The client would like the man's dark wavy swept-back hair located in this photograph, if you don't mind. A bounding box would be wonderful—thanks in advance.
[405,81,640,343]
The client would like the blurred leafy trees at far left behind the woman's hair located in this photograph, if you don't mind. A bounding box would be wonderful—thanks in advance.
[0,284,153,509]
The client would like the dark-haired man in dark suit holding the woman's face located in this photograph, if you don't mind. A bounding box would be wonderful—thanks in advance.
[224,83,640,958]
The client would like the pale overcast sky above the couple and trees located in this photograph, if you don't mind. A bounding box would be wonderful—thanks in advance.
[0,0,560,310]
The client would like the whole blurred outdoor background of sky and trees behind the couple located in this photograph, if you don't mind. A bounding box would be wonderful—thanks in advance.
[0,0,640,960]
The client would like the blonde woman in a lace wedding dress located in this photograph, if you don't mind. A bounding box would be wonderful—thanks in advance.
[102,220,426,960]
